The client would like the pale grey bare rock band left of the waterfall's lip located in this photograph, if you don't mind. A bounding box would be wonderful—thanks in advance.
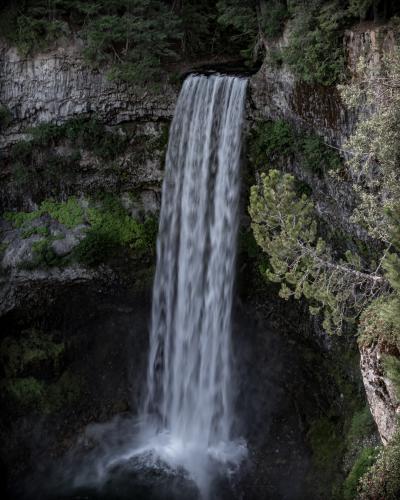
[0,43,177,149]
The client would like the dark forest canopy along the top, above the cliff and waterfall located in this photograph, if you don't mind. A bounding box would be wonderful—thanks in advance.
[0,0,400,85]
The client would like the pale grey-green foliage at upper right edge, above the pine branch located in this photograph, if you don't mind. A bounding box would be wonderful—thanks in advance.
[341,48,400,245]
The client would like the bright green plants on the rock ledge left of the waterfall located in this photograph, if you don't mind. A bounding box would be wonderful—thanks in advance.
[4,195,158,269]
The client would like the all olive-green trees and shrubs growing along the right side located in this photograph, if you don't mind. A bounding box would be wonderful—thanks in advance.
[249,36,400,499]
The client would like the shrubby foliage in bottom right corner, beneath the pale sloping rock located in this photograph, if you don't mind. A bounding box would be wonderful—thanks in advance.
[359,432,400,500]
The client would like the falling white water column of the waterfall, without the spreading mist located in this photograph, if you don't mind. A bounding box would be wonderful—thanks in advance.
[144,75,247,492]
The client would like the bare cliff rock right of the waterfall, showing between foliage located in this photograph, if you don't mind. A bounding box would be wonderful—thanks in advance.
[249,23,400,444]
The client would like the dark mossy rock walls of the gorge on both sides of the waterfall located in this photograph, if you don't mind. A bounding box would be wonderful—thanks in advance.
[0,10,400,499]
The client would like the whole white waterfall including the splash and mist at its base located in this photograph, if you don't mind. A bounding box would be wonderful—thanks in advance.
[66,75,247,500]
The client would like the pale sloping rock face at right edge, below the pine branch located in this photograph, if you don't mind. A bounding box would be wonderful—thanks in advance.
[360,345,400,444]
